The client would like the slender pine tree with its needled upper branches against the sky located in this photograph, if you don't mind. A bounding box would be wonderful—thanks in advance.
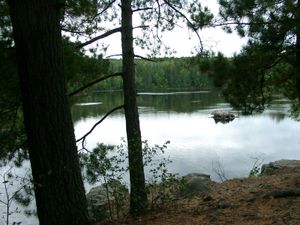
[65,0,213,215]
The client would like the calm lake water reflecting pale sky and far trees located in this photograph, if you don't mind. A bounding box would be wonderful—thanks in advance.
[72,91,300,181]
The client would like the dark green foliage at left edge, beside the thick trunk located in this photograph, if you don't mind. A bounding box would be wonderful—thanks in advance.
[0,37,26,159]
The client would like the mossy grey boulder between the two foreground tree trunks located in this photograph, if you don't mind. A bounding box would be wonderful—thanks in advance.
[86,180,129,222]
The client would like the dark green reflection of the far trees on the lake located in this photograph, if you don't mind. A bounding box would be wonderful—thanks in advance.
[72,90,228,122]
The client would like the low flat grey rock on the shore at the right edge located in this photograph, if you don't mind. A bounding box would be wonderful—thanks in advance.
[261,159,300,176]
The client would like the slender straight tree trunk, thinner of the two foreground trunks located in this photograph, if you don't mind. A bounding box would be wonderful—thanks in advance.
[121,0,147,215]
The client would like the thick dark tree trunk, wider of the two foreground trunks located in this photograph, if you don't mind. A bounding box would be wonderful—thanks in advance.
[8,0,87,225]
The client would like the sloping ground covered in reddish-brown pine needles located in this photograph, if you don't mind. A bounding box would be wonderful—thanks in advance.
[99,168,300,225]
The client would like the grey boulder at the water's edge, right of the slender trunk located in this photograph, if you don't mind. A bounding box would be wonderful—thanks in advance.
[178,173,214,198]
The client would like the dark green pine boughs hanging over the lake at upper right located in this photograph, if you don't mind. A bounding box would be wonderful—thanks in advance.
[214,0,300,115]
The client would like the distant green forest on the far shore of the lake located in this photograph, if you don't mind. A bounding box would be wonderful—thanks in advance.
[94,58,212,91]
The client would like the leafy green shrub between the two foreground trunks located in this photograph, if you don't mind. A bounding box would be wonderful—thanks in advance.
[79,140,128,220]
